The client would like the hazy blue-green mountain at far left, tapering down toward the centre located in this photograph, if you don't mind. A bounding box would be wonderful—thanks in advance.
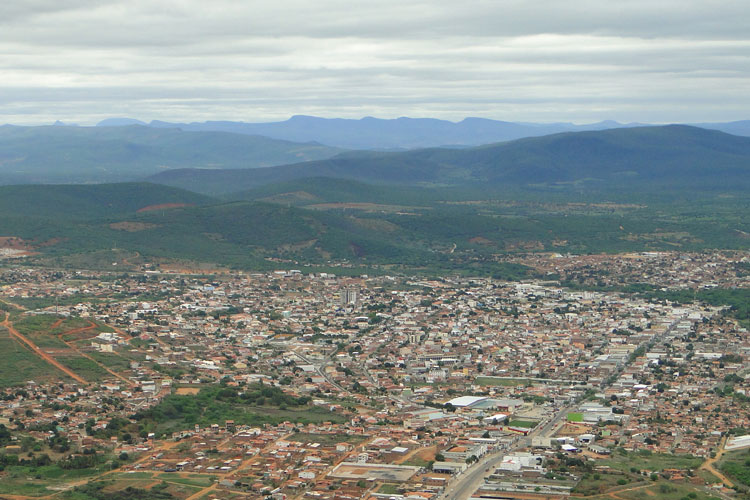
[0,125,342,184]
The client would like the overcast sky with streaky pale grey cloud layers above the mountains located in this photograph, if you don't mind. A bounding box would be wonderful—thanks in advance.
[0,0,750,125]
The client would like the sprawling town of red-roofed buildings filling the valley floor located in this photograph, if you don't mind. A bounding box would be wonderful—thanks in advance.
[0,251,750,500]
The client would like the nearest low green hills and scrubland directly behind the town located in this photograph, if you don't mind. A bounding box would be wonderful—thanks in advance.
[0,178,750,277]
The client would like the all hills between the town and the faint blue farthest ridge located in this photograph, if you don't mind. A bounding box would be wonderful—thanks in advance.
[0,119,750,277]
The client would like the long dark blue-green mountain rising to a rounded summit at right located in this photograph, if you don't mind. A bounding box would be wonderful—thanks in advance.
[149,125,750,193]
